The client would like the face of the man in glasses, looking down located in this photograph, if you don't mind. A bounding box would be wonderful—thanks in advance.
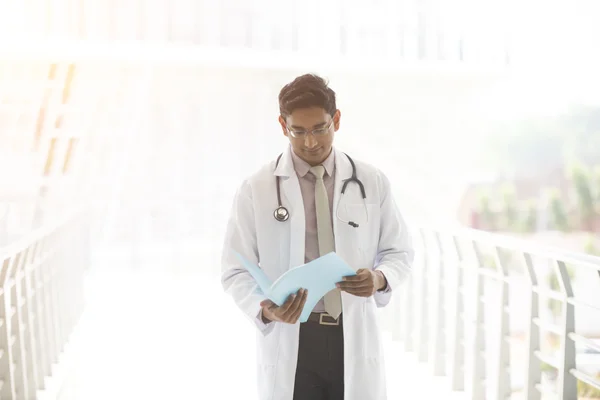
[279,107,341,165]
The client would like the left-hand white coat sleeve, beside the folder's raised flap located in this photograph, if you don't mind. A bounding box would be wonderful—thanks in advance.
[221,182,275,335]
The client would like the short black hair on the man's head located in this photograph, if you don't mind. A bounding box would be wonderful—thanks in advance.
[279,74,337,118]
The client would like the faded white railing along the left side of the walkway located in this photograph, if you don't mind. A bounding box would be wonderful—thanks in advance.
[0,212,89,400]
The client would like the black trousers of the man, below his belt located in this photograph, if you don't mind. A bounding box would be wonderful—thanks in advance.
[294,316,344,400]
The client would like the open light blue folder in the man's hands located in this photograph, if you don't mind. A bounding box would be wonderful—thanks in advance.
[235,252,356,322]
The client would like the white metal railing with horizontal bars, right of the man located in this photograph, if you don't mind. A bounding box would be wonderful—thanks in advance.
[392,228,600,400]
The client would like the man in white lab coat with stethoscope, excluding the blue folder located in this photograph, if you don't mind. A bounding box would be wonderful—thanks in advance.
[222,75,413,400]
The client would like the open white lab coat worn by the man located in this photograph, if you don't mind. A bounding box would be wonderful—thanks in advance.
[222,147,413,400]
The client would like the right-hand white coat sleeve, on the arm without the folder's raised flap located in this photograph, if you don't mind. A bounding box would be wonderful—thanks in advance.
[374,172,414,307]
